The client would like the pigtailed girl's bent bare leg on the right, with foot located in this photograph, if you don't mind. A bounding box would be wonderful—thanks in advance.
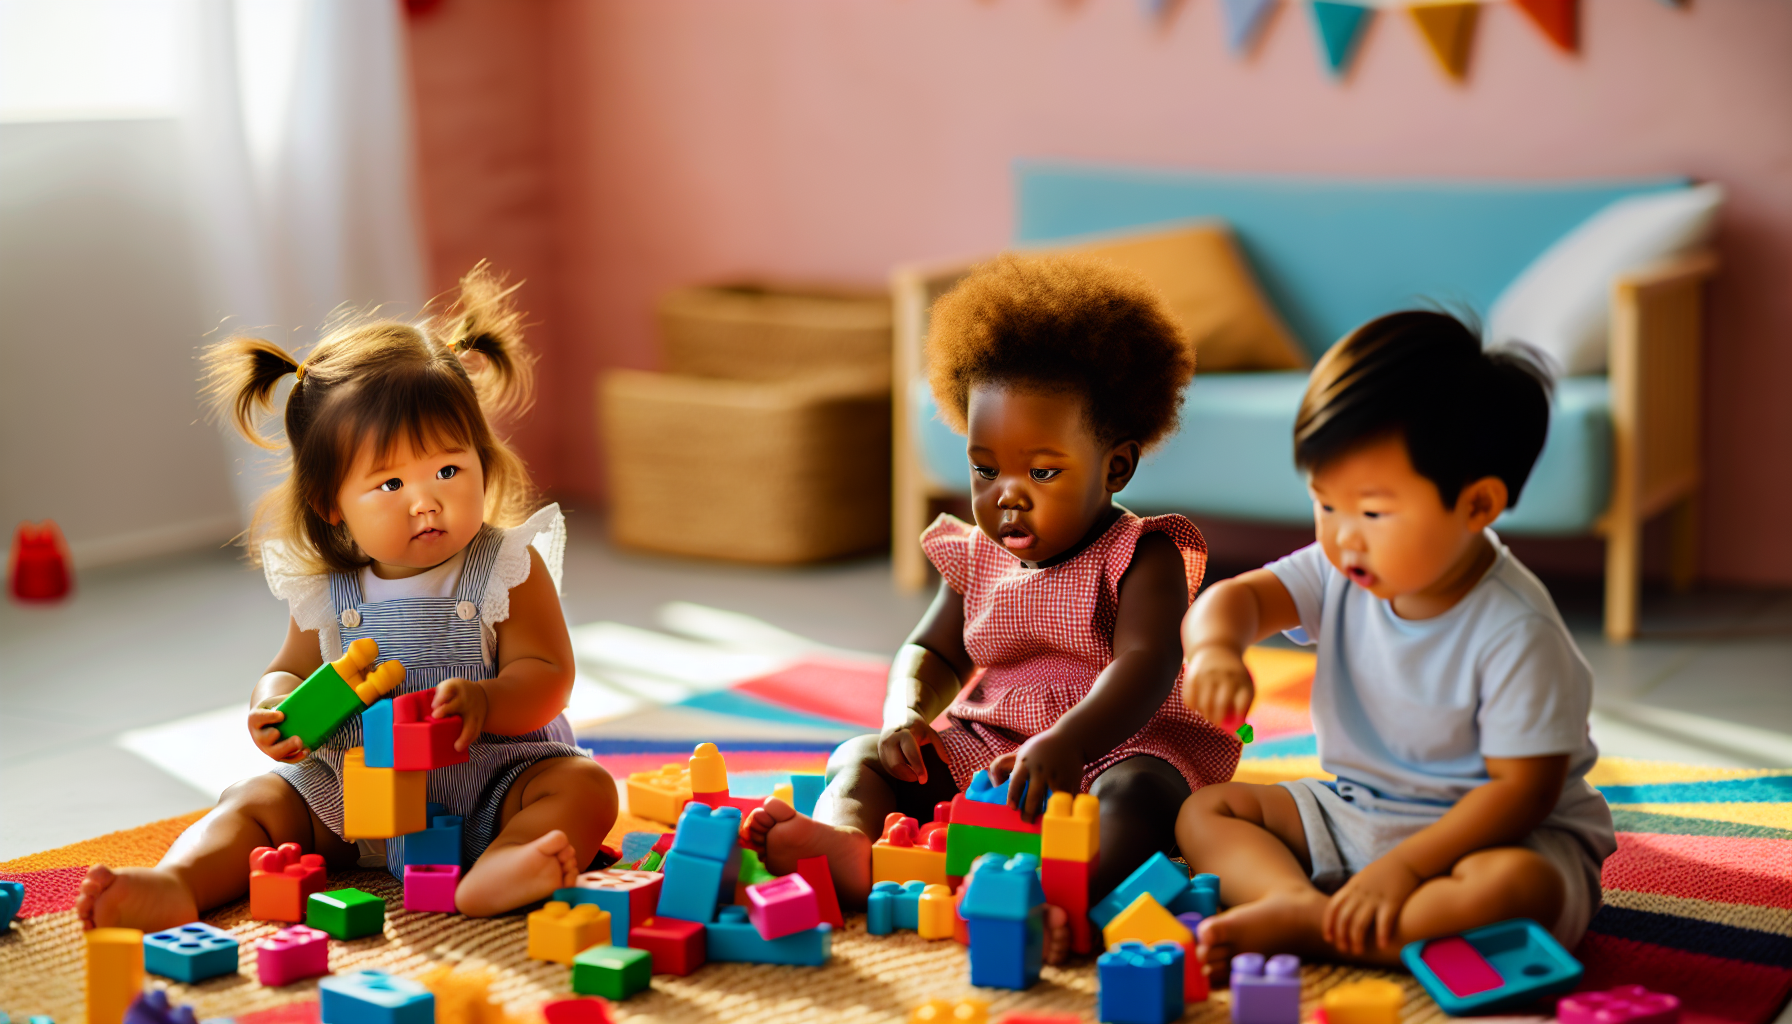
[453,757,616,916]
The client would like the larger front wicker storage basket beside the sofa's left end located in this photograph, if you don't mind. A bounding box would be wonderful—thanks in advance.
[599,369,891,563]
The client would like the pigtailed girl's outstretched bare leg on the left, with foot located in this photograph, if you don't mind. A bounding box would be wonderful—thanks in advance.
[75,773,357,931]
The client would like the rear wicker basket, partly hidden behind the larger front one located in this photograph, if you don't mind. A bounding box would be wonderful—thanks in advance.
[659,285,891,387]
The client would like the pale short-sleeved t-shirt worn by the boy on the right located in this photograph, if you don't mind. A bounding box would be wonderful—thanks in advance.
[1269,529,1616,854]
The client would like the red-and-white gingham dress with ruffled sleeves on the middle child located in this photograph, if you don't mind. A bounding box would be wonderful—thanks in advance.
[921,513,1244,793]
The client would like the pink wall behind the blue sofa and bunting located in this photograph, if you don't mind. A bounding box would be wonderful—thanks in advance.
[406,0,1792,583]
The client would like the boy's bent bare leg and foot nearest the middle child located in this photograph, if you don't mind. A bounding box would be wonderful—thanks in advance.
[1176,782,1335,965]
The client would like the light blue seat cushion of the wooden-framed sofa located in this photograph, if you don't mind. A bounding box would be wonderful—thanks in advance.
[909,371,1611,536]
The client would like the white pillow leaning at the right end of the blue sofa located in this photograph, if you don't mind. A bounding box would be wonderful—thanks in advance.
[1487,185,1724,375]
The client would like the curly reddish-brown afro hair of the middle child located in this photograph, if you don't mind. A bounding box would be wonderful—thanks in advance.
[926,255,1195,448]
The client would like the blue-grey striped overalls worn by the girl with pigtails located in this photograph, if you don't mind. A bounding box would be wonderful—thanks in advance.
[274,525,588,879]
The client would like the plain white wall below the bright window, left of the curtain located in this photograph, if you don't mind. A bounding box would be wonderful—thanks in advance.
[0,118,238,570]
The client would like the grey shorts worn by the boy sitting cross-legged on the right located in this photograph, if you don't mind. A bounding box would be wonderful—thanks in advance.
[1278,778,1600,950]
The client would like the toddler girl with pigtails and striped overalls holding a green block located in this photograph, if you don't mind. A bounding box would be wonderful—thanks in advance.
[77,264,616,931]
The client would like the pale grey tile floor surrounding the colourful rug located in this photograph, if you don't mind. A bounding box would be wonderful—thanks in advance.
[0,518,1792,859]
